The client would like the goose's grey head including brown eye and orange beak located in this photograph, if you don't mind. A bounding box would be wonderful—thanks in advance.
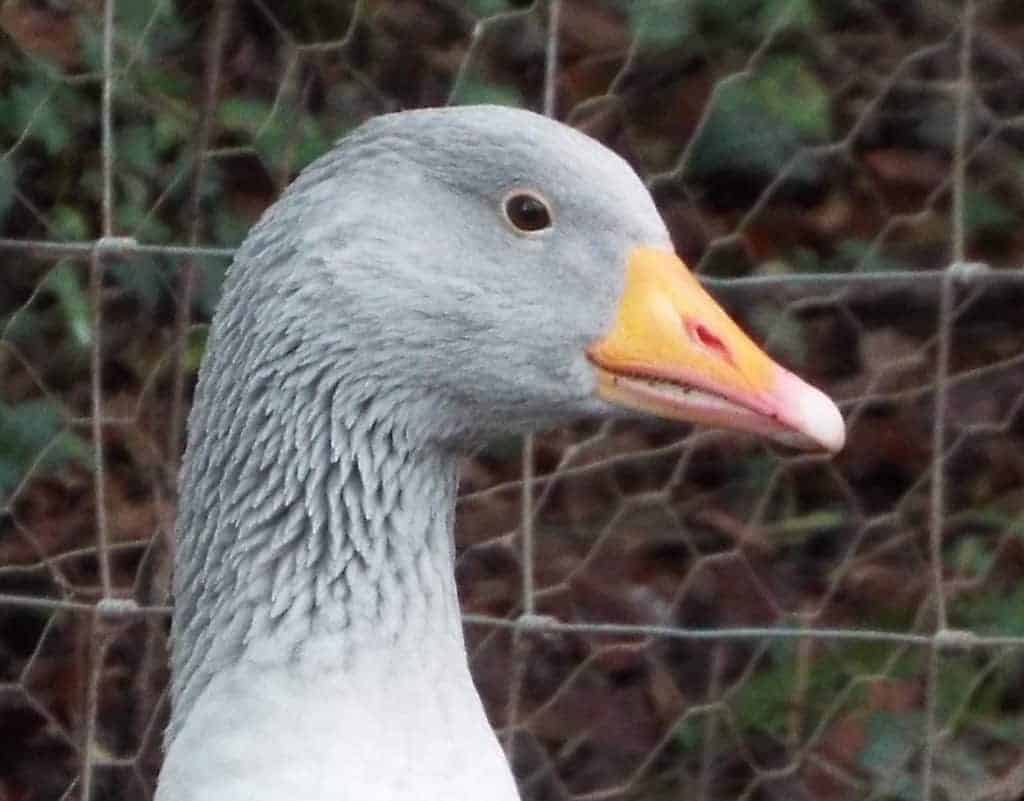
[228,107,844,451]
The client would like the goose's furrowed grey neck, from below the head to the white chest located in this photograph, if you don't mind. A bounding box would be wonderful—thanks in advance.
[171,370,465,736]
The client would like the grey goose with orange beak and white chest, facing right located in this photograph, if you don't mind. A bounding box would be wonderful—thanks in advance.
[156,107,845,801]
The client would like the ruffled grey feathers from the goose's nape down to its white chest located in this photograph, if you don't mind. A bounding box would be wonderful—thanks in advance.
[168,232,461,742]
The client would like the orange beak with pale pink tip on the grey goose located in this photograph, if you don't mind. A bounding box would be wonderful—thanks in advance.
[587,248,846,453]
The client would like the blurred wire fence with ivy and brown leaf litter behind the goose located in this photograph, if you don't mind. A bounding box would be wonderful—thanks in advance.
[0,0,1024,801]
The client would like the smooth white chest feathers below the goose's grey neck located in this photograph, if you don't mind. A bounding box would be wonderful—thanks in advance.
[157,638,519,801]
